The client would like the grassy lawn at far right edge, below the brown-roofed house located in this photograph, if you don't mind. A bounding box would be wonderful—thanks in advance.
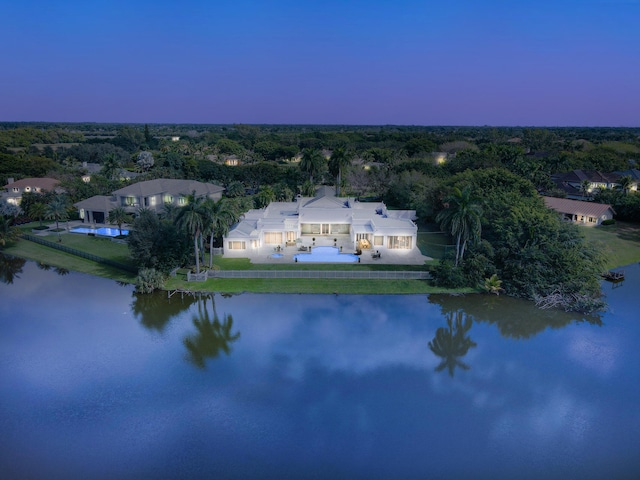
[582,222,640,270]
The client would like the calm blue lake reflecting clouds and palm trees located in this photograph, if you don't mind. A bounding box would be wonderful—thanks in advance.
[0,257,640,479]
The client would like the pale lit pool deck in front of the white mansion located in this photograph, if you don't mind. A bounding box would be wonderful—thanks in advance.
[225,240,432,265]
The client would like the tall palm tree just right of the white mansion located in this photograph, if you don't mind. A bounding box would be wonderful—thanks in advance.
[436,187,482,266]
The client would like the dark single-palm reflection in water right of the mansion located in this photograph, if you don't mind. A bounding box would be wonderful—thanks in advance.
[429,310,476,377]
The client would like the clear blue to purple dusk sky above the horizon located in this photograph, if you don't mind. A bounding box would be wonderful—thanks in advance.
[0,0,640,127]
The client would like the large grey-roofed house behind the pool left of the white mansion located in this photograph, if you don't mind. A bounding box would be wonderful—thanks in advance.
[75,179,224,223]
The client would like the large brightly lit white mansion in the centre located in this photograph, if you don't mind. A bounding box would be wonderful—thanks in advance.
[224,188,418,256]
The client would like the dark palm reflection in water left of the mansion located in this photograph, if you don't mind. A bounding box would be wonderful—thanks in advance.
[184,295,240,368]
